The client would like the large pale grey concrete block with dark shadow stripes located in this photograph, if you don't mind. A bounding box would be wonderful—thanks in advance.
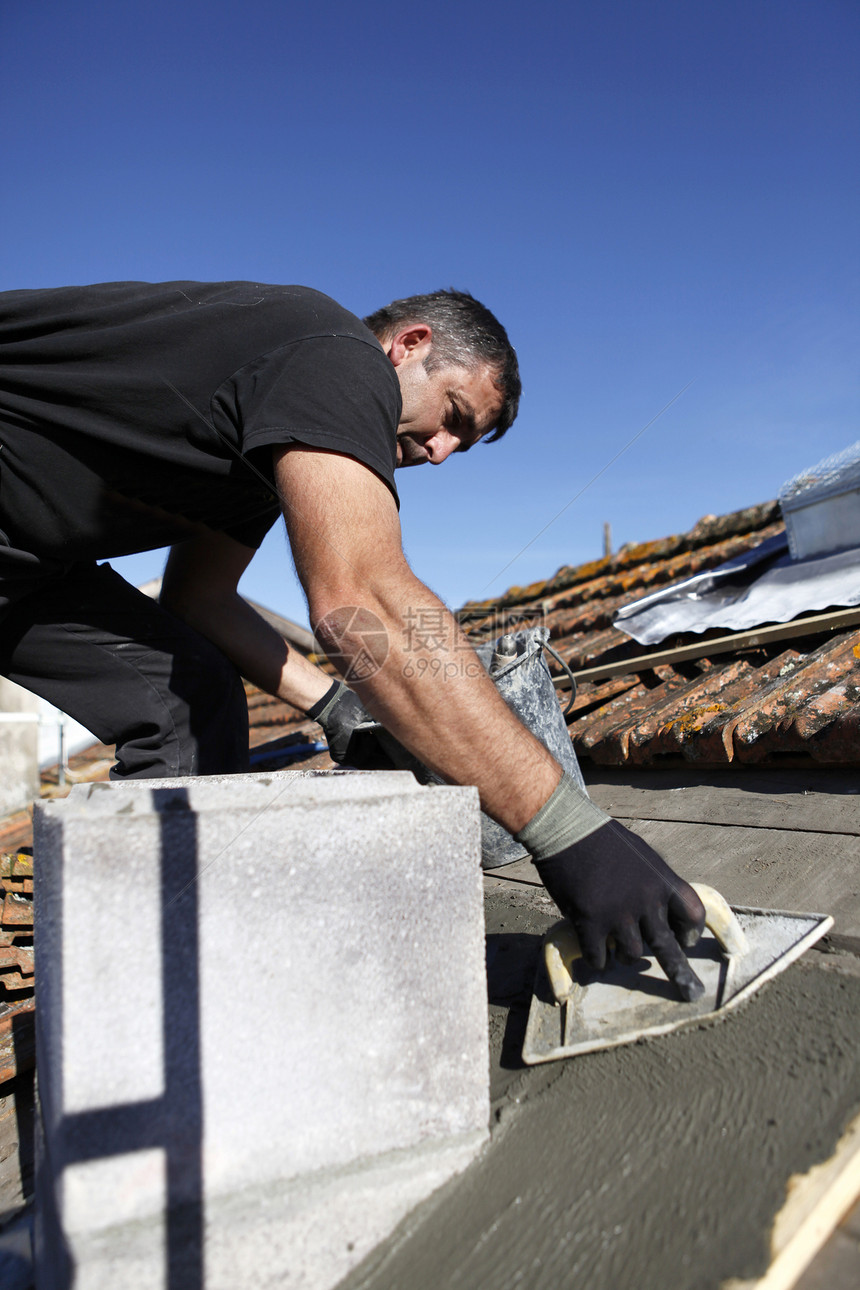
[36,771,489,1290]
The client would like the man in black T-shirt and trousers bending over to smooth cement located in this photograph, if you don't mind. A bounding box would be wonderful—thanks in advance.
[0,283,704,998]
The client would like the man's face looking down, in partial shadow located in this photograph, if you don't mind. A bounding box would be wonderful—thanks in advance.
[397,357,503,467]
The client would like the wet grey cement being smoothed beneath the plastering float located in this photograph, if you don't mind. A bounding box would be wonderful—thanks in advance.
[343,891,860,1290]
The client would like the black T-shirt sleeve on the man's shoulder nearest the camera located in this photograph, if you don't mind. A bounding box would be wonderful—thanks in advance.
[213,333,401,504]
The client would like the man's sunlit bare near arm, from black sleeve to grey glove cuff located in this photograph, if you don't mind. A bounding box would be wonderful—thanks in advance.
[275,446,561,832]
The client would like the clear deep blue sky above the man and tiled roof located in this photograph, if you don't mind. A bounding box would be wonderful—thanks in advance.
[0,0,860,620]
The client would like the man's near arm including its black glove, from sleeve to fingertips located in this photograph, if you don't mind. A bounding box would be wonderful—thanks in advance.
[275,448,705,998]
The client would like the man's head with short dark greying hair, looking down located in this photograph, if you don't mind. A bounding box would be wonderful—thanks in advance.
[365,290,521,466]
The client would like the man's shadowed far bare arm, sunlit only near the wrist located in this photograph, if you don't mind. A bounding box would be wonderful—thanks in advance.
[159,531,331,712]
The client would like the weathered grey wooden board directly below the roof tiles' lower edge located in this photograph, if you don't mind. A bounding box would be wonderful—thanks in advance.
[588,771,860,837]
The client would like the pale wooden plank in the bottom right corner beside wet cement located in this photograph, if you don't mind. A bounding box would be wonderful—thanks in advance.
[722,1116,860,1290]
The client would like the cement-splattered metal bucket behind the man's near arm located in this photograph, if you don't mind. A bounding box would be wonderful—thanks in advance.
[370,627,587,869]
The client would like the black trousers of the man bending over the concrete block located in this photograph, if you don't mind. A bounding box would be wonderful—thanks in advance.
[0,564,248,779]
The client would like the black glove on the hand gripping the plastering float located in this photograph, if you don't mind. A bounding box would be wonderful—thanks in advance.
[535,820,705,1001]
